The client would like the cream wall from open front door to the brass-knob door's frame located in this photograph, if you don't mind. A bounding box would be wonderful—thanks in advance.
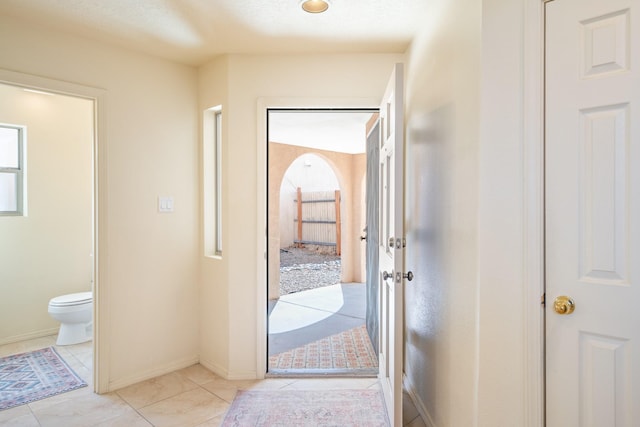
[405,0,542,426]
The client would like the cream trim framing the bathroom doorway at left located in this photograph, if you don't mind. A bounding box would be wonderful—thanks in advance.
[0,69,109,393]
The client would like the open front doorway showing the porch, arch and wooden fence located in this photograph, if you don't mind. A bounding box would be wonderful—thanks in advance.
[267,109,378,375]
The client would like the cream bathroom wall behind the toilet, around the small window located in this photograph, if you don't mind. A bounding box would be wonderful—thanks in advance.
[0,85,93,344]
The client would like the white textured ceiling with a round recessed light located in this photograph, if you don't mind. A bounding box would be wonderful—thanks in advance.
[0,0,430,65]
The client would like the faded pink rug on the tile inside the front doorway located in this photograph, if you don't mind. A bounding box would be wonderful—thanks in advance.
[221,389,389,427]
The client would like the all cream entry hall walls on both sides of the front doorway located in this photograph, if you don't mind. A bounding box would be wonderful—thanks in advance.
[0,0,540,426]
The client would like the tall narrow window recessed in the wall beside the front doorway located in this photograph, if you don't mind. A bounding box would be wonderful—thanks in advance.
[208,106,222,256]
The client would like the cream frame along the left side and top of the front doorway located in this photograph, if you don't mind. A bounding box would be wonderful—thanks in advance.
[256,97,380,379]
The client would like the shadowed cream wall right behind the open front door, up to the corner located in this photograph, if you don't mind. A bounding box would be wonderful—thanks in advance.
[405,0,482,426]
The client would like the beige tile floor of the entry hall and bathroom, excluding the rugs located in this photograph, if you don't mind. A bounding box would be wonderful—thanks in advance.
[0,336,425,427]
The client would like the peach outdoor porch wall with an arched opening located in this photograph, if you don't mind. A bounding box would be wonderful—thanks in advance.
[268,142,367,299]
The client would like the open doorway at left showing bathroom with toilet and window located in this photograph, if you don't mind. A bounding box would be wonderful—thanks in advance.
[0,81,96,392]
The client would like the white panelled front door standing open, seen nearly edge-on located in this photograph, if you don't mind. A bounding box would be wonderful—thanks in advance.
[378,64,404,426]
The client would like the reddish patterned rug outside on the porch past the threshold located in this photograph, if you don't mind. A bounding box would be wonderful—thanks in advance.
[269,325,378,369]
